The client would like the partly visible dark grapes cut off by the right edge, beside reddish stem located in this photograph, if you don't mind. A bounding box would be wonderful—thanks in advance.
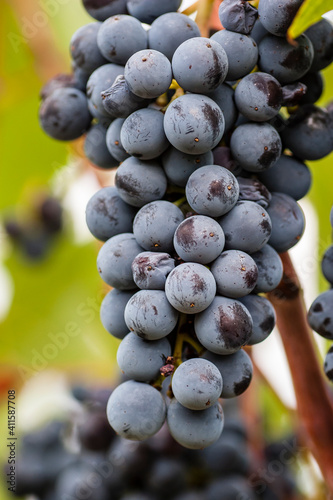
[308,203,333,382]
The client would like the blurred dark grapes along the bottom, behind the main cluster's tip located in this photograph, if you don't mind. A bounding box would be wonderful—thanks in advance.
[4,386,299,500]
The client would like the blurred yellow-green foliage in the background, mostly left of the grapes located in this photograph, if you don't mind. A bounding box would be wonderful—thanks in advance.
[0,0,333,498]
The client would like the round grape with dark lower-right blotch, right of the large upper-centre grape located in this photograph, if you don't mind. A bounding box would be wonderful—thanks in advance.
[230,123,282,172]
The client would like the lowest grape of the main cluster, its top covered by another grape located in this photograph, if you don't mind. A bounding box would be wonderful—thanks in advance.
[167,399,224,450]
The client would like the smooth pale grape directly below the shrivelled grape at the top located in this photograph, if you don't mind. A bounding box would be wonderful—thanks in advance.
[211,29,258,82]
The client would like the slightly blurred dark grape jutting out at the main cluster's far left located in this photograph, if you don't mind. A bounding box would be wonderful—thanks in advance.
[39,87,91,141]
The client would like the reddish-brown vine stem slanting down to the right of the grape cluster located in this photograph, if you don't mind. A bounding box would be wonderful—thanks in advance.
[268,253,333,494]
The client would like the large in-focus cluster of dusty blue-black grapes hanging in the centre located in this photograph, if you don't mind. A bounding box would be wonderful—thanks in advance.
[40,0,333,449]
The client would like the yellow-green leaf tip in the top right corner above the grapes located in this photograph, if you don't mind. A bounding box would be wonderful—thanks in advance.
[288,0,332,39]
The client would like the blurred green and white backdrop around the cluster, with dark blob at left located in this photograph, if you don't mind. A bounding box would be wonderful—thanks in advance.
[0,0,333,499]
